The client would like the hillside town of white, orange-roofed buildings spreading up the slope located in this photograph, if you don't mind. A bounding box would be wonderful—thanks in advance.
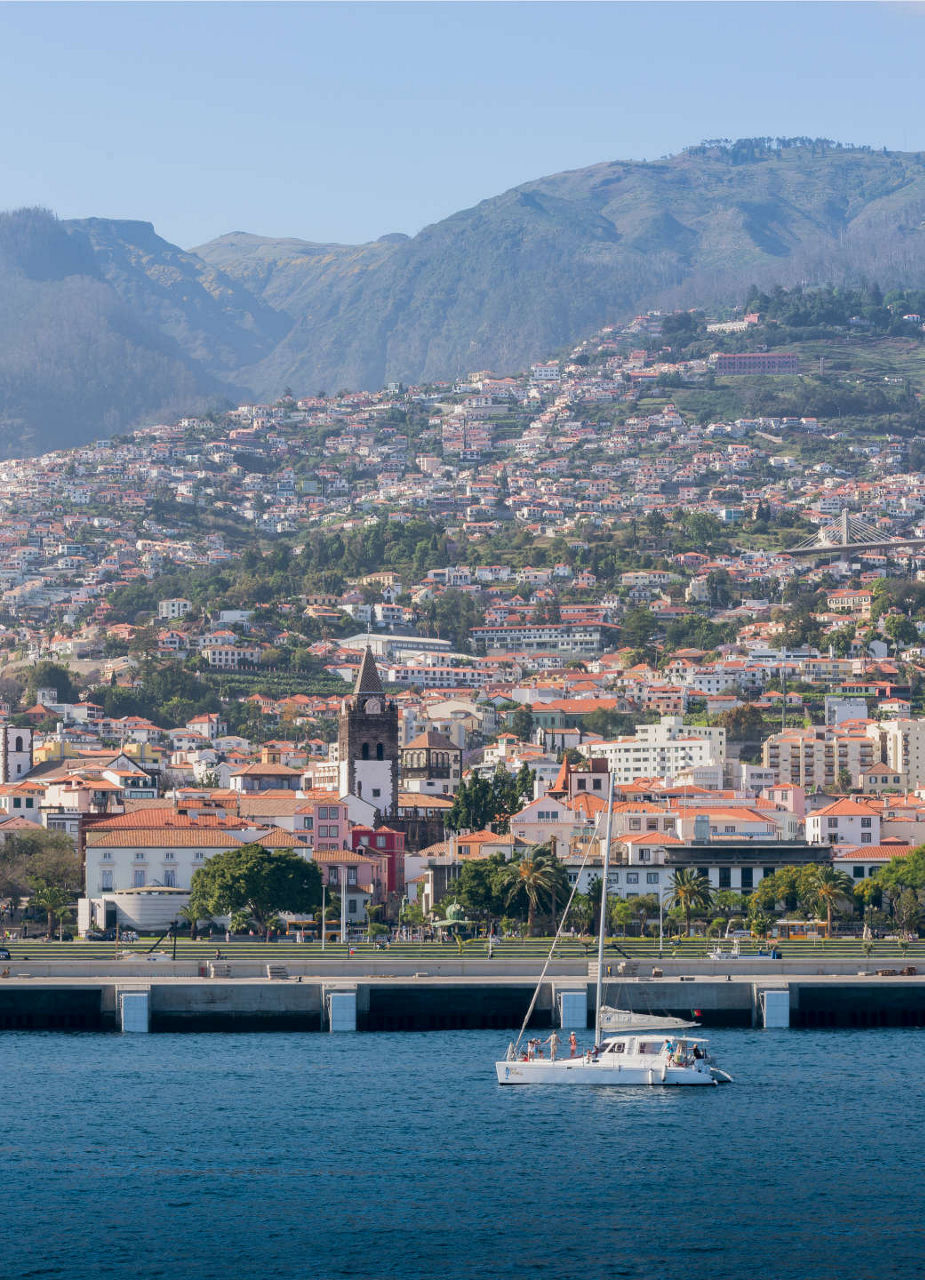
[0,296,925,933]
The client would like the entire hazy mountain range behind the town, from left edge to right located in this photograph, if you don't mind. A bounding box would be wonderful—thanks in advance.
[0,138,925,456]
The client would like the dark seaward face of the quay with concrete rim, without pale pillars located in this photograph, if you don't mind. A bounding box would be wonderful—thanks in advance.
[0,970,925,1032]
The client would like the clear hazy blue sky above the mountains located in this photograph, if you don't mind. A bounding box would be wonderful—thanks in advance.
[0,3,925,247]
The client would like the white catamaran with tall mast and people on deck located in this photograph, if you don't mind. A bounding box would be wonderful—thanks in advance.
[495,774,732,1087]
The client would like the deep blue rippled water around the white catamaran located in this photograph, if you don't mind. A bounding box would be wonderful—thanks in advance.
[0,1030,925,1280]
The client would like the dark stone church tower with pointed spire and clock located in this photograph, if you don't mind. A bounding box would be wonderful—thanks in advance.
[338,649,398,818]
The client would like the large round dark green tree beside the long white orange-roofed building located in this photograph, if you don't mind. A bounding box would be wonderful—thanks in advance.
[189,844,321,931]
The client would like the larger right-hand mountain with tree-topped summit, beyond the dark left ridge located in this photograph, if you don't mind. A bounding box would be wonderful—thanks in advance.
[194,140,925,394]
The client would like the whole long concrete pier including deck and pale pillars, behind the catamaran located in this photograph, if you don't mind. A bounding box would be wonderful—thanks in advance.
[0,959,925,1033]
